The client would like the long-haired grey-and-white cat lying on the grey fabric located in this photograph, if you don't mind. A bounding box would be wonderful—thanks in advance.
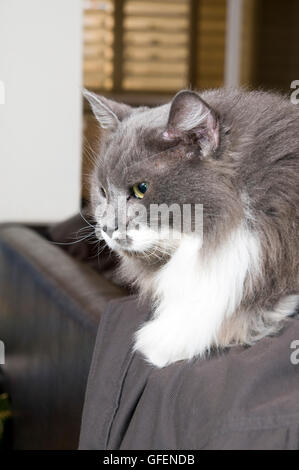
[85,89,299,367]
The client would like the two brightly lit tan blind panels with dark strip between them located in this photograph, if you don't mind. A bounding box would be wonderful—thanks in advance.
[84,0,192,92]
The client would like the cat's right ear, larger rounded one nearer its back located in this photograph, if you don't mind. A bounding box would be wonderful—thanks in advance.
[163,90,219,156]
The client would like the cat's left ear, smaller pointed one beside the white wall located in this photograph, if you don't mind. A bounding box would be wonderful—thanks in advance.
[83,89,132,131]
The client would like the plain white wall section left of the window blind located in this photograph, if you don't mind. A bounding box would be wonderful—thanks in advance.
[0,0,82,222]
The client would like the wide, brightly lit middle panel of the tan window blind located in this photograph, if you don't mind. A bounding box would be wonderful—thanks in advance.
[123,0,190,91]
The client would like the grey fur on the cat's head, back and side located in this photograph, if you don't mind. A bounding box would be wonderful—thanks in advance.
[87,89,299,345]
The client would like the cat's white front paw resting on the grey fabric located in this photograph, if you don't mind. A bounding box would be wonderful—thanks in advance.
[134,319,197,367]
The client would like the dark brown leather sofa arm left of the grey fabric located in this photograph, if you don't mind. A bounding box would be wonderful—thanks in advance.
[0,225,125,449]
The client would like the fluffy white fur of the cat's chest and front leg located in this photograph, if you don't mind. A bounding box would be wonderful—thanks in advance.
[134,226,259,367]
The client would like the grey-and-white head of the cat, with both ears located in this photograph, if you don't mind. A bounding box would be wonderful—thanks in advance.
[84,90,231,260]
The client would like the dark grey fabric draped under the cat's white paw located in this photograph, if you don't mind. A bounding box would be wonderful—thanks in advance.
[80,297,299,450]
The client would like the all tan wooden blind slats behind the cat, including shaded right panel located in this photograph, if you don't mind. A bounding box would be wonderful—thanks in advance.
[84,0,226,92]
